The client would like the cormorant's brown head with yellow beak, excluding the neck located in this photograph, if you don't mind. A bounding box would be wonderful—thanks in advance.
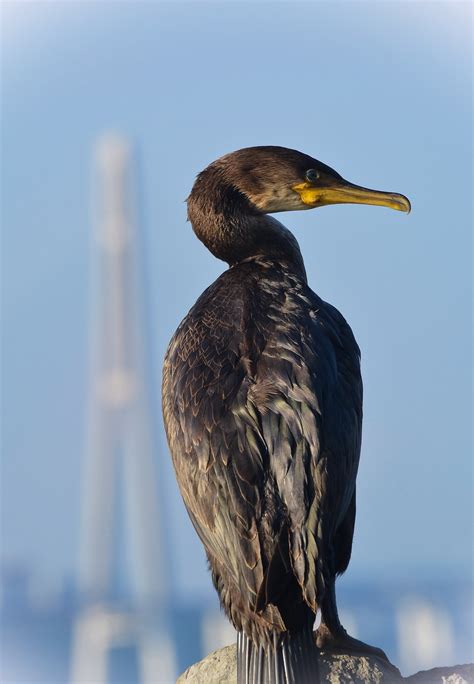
[204,146,410,214]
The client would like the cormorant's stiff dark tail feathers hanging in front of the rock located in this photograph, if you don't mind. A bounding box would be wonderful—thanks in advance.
[237,627,320,684]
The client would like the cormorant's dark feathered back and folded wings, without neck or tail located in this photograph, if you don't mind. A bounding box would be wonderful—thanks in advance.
[163,257,362,643]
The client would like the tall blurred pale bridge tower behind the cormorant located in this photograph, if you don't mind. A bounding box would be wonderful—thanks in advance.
[71,135,176,684]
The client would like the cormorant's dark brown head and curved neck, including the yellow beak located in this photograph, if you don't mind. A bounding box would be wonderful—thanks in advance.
[188,147,410,270]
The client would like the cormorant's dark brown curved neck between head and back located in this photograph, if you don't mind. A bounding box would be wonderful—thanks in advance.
[188,179,306,280]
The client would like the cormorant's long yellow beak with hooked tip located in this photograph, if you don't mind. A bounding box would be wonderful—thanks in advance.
[292,178,411,214]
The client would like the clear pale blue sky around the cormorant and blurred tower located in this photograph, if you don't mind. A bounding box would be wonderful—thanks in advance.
[1,1,472,594]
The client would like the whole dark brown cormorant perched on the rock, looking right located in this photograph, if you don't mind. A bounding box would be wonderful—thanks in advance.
[162,146,410,684]
